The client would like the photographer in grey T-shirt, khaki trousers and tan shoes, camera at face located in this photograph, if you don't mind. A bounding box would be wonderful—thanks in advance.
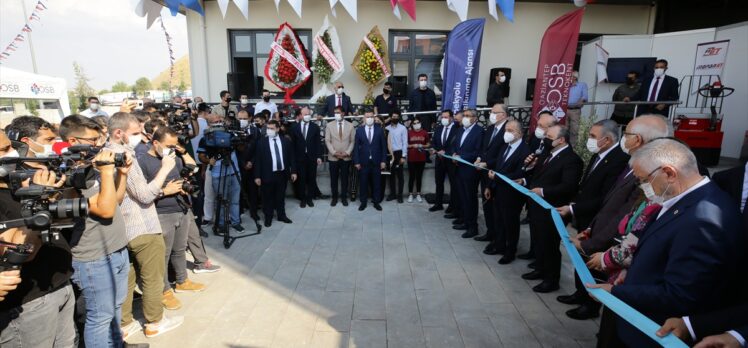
[138,127,205,310]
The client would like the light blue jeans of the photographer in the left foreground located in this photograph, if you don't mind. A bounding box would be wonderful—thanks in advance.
[72,248,130,348]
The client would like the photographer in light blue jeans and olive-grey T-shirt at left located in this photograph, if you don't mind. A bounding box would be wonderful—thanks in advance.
[57,115,130,347]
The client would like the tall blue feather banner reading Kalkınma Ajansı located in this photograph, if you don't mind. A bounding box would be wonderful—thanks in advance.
[442,18,486,112]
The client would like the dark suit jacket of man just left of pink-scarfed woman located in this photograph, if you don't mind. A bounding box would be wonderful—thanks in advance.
[581,166,644,255]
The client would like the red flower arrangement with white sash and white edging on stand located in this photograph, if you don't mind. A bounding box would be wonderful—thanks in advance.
[265,23,312,104]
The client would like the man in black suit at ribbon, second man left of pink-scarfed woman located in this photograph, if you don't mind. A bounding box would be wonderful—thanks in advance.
[556,120,629,320]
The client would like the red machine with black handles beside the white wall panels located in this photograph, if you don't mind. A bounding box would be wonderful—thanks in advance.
[673,80,735,166]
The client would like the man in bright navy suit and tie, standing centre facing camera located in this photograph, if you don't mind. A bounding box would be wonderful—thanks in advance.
[353,110,387,210]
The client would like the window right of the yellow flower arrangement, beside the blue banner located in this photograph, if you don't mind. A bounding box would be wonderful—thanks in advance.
[389,30,449,99]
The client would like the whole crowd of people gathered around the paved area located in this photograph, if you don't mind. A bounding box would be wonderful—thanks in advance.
[0,60,748,347]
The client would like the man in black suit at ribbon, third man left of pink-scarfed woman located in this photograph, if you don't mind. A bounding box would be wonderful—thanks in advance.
[522,125,584,293]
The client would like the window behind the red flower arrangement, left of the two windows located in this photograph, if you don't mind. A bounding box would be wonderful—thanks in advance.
[228,29,313,99]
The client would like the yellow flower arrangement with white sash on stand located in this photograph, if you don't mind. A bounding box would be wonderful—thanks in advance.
[352,26,390,105]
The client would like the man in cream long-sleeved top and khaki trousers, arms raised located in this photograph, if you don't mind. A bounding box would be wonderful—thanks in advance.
[107,112,184,337]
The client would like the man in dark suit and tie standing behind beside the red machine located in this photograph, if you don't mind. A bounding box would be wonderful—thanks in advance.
[634,59,680,116]
